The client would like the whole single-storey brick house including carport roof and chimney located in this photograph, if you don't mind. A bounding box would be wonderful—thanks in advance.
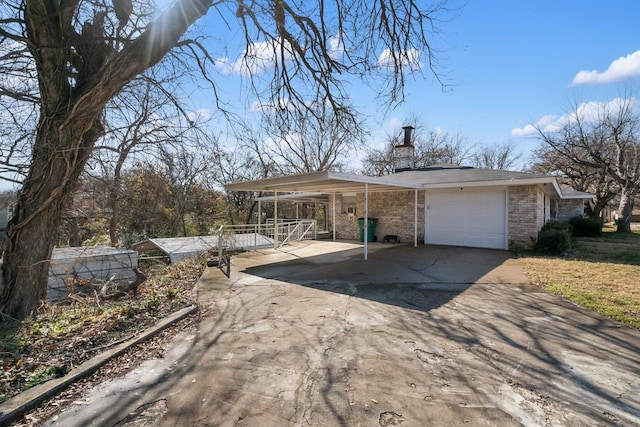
[225,128,593,252]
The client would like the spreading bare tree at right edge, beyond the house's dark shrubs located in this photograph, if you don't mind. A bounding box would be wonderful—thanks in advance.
[537,97,640,232]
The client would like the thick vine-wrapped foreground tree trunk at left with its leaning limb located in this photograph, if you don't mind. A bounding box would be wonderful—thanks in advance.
[0,0,211,319]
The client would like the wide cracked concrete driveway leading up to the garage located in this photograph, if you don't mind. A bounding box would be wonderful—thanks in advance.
[49,242,640,427]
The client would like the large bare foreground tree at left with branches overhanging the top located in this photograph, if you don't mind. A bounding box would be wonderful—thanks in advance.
[0,0,452,318]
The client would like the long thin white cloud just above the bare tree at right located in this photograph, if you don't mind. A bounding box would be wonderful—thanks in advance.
[511,98,639,136]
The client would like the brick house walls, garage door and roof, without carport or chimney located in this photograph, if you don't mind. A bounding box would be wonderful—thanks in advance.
[329,165,592,249]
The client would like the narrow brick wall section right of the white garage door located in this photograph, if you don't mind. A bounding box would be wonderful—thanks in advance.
[508,185,544,249]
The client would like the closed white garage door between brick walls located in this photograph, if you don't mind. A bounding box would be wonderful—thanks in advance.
[425,189,507,249]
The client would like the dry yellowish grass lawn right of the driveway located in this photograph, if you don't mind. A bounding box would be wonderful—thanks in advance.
[519,227,640,329]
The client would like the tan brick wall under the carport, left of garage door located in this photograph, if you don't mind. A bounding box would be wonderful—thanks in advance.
[327,191,424,243]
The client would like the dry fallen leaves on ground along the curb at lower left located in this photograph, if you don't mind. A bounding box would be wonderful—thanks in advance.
[0,260,204,425]
